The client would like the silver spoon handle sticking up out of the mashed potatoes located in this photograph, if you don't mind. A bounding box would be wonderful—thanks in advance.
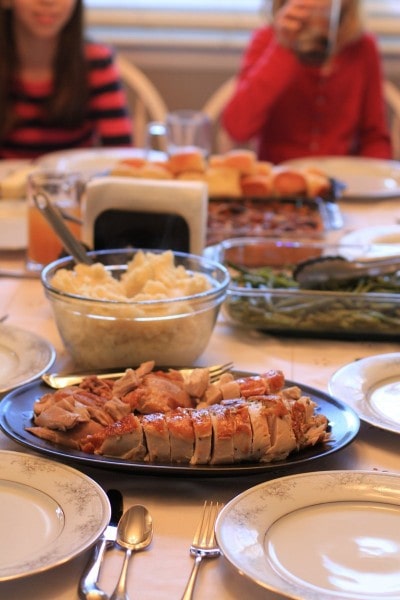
[33,192,93,265]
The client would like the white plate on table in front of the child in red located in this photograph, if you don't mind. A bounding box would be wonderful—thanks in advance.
[285,156,400,200]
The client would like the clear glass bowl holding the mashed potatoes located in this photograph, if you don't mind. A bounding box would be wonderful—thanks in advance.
[41,249,229,370]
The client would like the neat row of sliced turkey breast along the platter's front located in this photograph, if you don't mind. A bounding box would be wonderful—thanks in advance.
[82,396,328,465]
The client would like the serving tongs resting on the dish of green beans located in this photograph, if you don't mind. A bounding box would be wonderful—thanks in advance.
[293,254,400,289]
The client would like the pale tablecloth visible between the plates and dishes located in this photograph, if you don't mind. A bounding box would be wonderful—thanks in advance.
[0,183,400,600]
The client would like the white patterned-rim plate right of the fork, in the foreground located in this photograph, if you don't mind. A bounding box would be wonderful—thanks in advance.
[216,471,400,600]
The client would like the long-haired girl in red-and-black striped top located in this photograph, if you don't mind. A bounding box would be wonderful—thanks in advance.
[0,0,132,159]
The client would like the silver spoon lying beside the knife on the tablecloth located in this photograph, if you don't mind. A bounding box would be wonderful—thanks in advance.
[110,504,153,600]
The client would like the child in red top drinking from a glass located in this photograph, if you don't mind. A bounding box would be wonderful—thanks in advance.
[222,0,392,163]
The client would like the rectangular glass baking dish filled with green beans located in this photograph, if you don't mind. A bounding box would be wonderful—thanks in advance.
[206,238,400,341]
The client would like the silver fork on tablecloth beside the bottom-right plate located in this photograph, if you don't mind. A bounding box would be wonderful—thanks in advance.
[181,500,223,600]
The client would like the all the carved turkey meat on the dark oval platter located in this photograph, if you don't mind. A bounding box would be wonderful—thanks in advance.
[27,360,329,465]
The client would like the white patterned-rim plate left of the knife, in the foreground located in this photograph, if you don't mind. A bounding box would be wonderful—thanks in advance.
[0,451,111,581]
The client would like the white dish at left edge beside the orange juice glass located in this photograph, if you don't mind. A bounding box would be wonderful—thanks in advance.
[0,200,28,250]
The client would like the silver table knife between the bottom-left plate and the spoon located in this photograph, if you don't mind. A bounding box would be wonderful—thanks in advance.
[78,490,124,600]
